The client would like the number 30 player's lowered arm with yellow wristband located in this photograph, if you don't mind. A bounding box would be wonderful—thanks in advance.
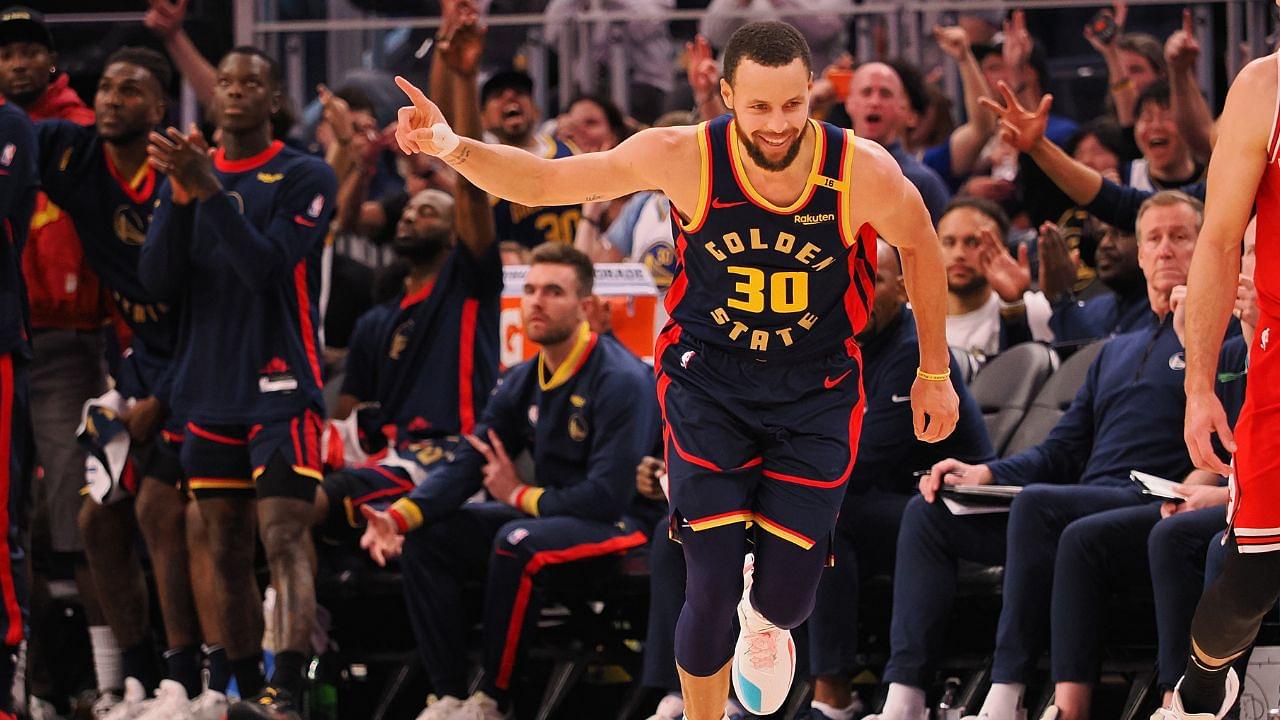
[850,138,960,442]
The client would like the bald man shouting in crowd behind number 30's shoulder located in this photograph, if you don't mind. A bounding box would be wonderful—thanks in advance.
[845,63,951,227]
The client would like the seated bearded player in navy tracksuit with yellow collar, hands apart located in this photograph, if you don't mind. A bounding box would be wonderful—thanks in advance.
[361,243,658,720]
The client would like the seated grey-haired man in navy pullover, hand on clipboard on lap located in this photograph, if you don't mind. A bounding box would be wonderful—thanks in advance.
[877,191,1233,720]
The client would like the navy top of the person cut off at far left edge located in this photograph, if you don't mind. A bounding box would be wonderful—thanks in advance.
[0,97,40,357]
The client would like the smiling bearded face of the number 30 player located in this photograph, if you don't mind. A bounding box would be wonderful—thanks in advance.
[721,58,813,172]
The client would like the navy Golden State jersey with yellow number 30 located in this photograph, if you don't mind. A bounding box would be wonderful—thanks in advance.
[663,115,876,360]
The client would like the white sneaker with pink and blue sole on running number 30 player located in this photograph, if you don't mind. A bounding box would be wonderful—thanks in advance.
[732,555,796,715]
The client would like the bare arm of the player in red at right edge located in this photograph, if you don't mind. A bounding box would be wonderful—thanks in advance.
[1184,56,1276,474]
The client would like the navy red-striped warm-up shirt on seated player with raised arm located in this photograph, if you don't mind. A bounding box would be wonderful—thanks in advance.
[342,245,502,441]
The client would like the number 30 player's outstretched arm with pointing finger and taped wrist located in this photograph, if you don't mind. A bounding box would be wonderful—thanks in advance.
[396,77,699,208]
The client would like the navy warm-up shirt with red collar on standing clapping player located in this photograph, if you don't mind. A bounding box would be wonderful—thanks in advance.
[140,141,337,424]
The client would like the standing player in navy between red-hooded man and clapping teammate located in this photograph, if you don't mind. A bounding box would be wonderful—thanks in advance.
[37,47,227,720]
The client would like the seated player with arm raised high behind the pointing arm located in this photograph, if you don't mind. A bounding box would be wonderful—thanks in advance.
[317,4,502,534]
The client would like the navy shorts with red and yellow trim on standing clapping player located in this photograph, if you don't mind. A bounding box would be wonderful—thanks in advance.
[182,410,324,502]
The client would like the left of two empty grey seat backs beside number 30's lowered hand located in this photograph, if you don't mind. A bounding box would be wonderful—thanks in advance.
[969,342,1057,455]
